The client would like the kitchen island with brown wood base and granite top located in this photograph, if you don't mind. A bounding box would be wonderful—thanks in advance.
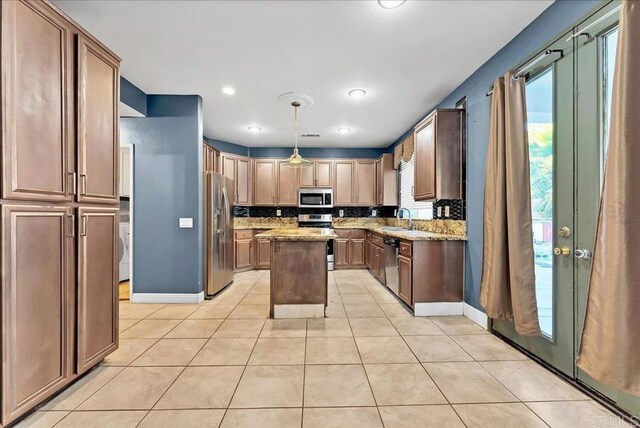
[255,227,337,318]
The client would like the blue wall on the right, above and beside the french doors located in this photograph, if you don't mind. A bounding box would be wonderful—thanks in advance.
[394,0,602,309]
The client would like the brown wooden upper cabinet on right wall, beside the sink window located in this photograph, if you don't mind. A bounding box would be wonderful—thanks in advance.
[414,109,462,201]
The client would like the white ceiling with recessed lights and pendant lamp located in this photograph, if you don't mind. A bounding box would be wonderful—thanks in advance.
[55,0,553,147]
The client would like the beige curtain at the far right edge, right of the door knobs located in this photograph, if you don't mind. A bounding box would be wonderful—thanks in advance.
[578,1,640,396]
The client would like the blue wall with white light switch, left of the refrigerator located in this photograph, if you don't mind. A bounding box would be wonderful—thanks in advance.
[120,95,202,294]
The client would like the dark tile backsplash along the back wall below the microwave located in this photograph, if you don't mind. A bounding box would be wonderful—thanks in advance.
[233,206,397,218]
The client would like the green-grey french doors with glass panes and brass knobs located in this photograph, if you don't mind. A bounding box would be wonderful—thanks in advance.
[492,1,640,416]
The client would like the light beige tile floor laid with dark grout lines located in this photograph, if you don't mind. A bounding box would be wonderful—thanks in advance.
[18,270,628,428]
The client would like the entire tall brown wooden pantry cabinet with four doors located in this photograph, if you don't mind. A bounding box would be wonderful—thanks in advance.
[0,0,120,425]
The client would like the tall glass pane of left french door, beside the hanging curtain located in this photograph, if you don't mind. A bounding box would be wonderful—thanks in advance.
[526,68,554,338]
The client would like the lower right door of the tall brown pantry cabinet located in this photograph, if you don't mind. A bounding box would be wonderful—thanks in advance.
[77,208,120,373]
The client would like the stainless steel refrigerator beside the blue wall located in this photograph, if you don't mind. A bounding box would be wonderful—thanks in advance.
[203,172,234,297]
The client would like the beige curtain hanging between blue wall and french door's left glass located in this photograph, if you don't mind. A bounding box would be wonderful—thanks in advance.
[480,73,540,336]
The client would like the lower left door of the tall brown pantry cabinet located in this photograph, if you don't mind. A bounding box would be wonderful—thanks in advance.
[1,205,75,424]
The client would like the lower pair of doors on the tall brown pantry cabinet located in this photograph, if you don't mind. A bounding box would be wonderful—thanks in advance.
[0,205,119,425]
